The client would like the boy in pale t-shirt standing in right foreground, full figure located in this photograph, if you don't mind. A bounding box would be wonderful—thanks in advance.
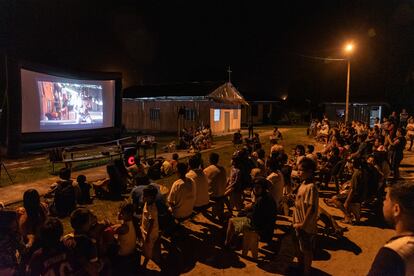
[293,157,319,275]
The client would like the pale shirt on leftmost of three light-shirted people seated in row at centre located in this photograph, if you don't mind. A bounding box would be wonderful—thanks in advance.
[168,178,195,218]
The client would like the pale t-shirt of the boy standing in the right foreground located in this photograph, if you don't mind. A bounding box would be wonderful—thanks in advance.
[293,183,319,234]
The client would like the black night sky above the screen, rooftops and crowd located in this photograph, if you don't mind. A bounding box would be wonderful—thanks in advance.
[0,0,414,102]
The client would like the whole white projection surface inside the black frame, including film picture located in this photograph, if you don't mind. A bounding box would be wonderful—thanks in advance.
[20,69,115,133]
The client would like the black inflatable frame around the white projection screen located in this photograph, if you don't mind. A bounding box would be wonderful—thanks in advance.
[2,58,122,156]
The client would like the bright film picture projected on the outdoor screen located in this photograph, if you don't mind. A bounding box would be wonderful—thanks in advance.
[37,81,103,130]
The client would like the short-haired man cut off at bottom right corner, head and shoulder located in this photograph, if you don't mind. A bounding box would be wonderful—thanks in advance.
[368,183,414,276]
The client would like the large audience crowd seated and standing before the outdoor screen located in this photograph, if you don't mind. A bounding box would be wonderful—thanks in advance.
[0,111,414,275]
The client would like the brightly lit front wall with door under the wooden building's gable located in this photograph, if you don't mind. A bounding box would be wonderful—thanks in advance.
[210,108,241,134]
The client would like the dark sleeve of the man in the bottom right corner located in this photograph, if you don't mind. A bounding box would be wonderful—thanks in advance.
[368,247,405,276]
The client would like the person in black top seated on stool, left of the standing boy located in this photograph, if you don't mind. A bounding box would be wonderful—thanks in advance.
[224,177,277,247]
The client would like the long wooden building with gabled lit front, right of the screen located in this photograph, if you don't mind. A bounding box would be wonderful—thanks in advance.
[122,82,247,134]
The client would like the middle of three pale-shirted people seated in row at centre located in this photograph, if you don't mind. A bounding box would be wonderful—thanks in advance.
[185,155,210,211]
